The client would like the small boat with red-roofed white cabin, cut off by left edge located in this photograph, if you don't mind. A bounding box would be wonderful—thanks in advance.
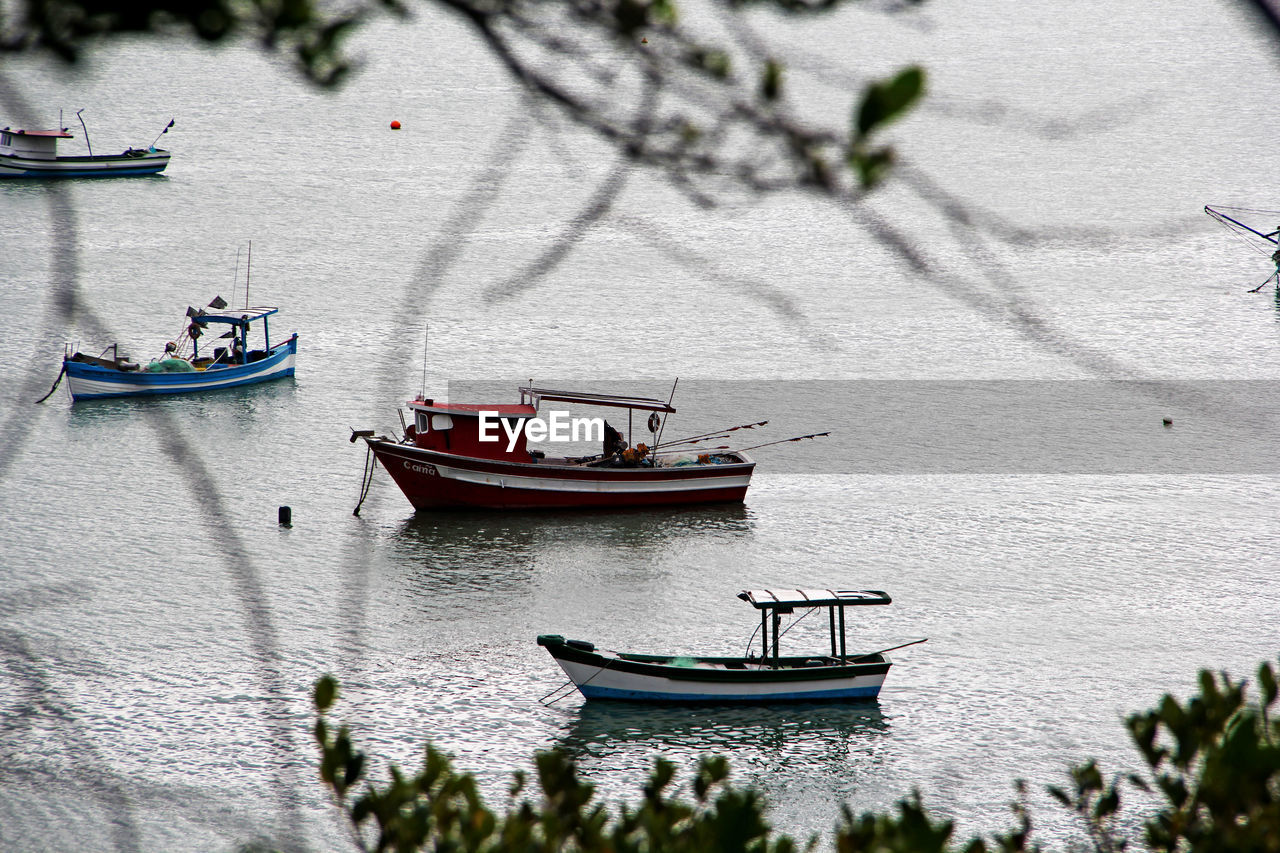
[0,113,173,178]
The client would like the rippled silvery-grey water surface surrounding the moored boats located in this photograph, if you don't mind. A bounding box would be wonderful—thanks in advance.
[0,1,1280,850]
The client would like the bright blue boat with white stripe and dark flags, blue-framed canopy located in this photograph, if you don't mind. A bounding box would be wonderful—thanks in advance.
[63,297,298,400]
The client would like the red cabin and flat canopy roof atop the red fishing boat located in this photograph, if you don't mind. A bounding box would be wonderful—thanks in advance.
[406,387,676,464]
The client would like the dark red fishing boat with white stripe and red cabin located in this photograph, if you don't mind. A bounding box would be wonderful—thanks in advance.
[351,388,755,514]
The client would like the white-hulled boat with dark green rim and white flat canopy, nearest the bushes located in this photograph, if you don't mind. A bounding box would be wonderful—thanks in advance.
[538,589,925,702]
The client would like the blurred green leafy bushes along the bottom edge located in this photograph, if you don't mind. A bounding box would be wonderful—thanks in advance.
[314,663,1280,853]
